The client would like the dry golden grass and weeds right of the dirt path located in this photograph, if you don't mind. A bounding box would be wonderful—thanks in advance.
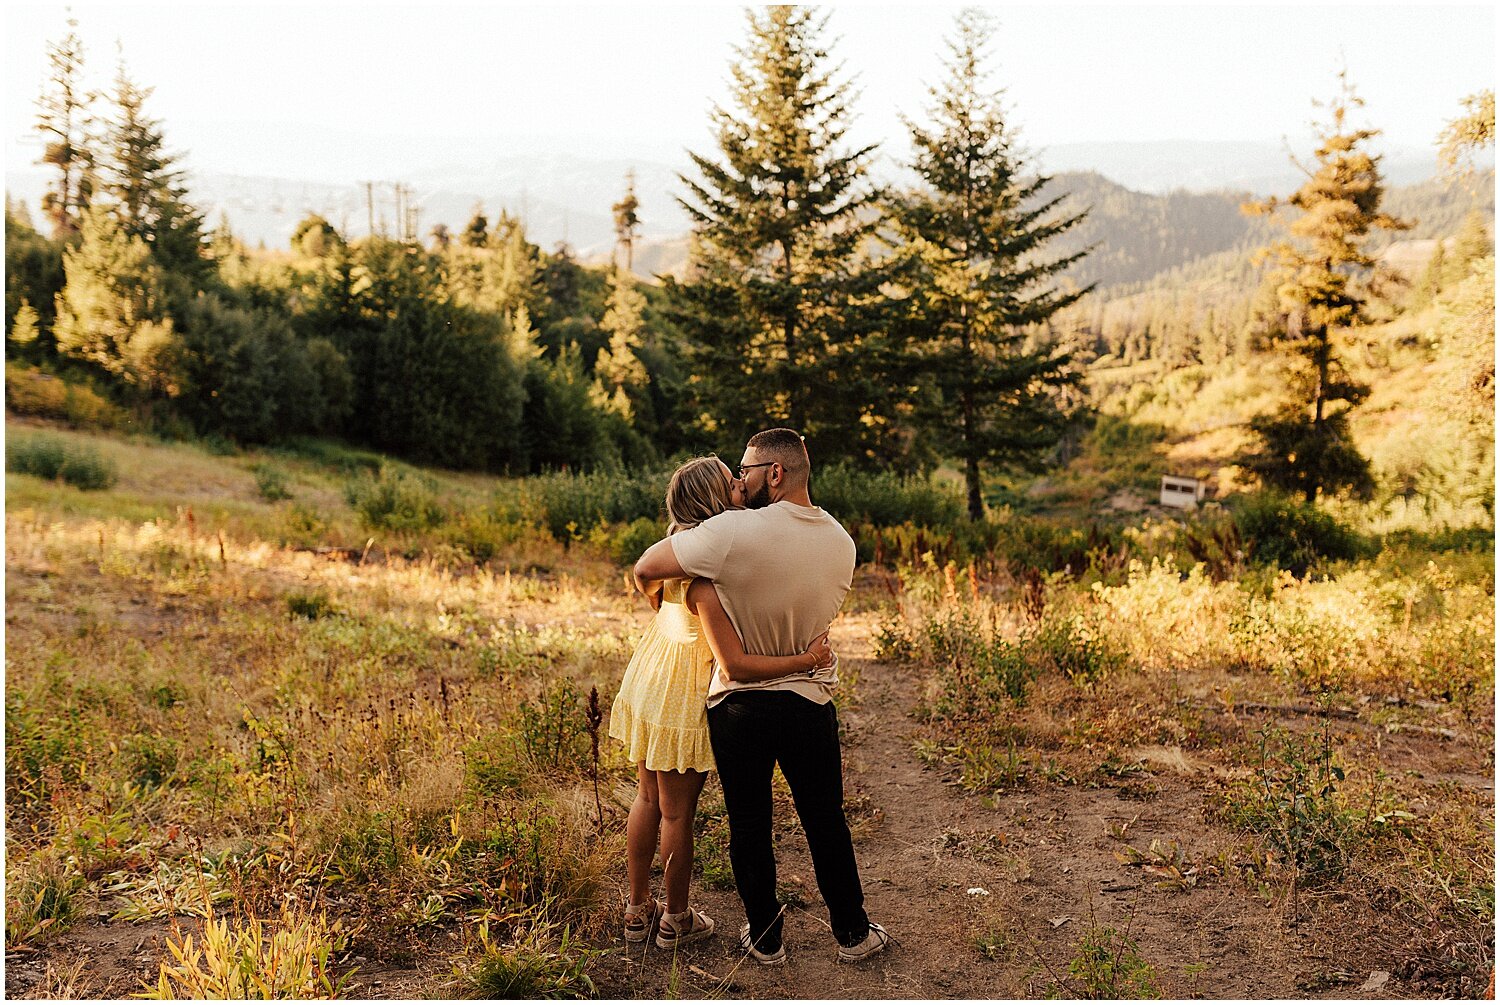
[878,554,1494,995]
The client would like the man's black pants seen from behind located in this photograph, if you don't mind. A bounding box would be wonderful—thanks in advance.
[708,692,870,951]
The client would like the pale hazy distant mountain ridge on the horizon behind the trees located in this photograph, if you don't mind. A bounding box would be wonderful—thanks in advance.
[6,143,1494,287]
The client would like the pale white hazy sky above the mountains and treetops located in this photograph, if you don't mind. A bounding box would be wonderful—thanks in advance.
[3,0,1496,182]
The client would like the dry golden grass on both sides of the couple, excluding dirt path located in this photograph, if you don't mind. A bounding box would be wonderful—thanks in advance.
[6,417,1494,996]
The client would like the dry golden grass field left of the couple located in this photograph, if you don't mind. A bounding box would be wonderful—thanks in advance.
[6,434,647,987]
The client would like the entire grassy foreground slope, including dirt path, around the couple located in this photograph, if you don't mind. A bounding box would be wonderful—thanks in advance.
[6,411,1494,998]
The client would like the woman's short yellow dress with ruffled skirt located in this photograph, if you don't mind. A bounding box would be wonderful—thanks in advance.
[609,579,714,771]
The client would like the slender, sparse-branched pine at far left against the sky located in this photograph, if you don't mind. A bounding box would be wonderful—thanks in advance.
[36,18,95,239]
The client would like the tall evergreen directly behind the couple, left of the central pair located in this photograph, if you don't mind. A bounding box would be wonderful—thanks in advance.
[666,6,902,465]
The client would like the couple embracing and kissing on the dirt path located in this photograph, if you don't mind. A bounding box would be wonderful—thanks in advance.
[609,429,891,966]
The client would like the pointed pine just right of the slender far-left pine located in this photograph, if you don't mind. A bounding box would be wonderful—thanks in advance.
[101,60,209,276]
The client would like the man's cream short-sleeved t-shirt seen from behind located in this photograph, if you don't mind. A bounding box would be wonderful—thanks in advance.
[668,501,854,705]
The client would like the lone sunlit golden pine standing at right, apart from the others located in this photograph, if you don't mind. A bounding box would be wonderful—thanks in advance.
[1242,71,1409,503]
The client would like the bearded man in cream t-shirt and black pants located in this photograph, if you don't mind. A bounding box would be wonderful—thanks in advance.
[636,429,891,966]
